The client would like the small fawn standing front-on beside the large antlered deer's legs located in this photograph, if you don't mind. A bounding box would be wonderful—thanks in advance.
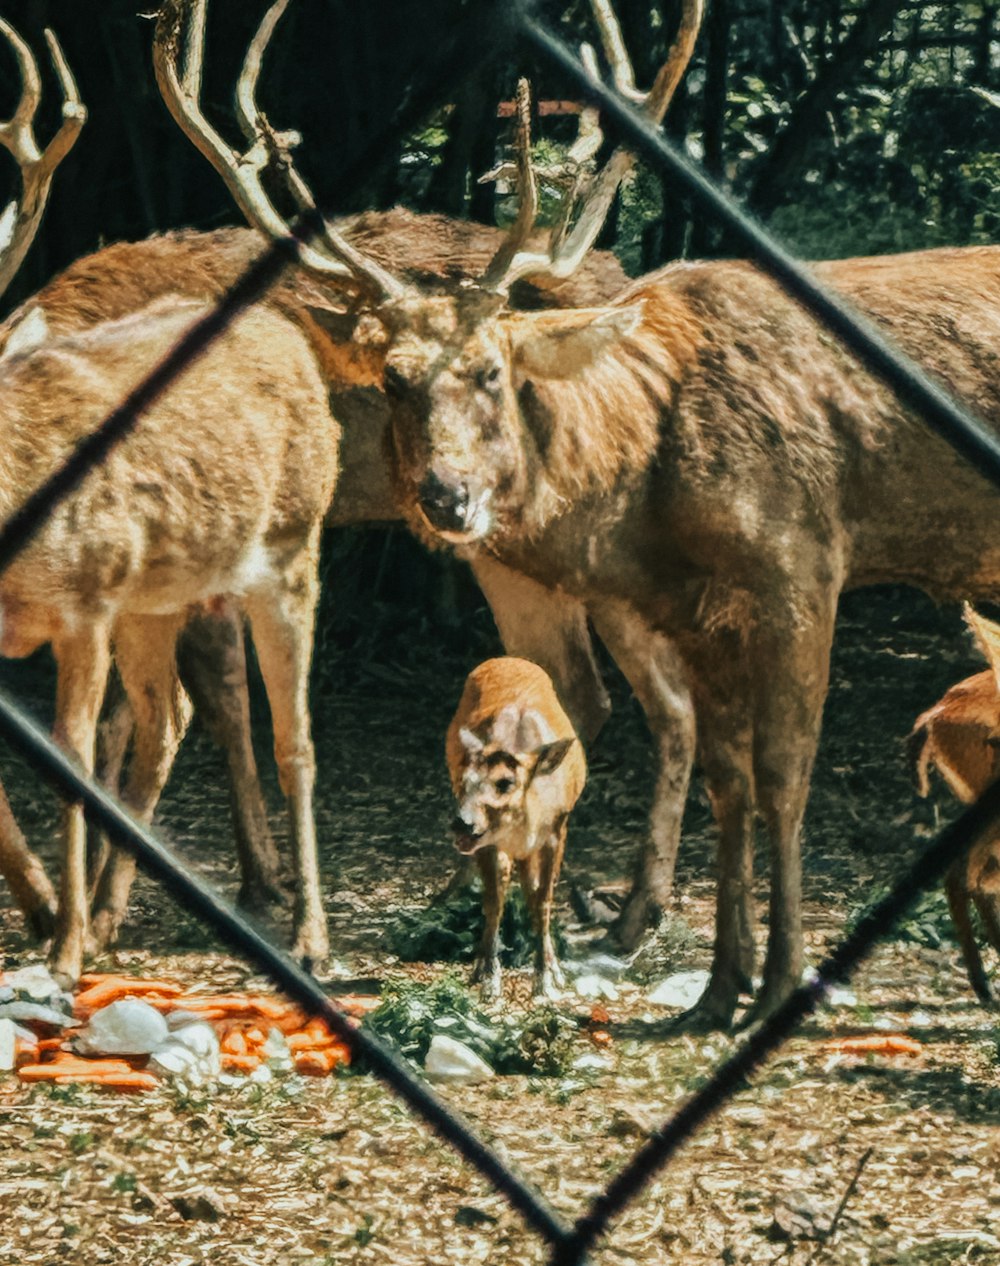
[446,656,586,999]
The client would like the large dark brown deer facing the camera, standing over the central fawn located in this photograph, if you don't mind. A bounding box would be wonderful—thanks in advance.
[278,7,1000,1025]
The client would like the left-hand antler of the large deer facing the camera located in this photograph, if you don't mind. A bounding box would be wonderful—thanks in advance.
[153,0,405,299]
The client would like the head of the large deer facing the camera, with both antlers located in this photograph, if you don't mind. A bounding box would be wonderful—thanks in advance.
[153,0,704,542]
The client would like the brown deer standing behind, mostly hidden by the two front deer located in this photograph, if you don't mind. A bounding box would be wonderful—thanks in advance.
[0,209,623,957]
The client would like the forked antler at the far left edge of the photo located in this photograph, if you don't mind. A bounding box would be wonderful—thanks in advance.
[0,18,87,301]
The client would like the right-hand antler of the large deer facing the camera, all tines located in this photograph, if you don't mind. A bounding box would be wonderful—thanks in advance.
[478,0,705,291]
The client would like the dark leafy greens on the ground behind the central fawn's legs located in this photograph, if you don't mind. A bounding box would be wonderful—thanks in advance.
[386,884,566,967]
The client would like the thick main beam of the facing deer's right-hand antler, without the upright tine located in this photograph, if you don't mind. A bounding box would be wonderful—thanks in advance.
[481,0,705,291]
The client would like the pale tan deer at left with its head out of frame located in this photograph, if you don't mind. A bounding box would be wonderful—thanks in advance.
[0,14,356,982]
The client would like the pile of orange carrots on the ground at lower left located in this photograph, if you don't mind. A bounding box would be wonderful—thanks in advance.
[3,974,380,1091]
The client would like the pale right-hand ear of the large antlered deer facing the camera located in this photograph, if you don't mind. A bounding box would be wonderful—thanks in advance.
[511,303,643,379]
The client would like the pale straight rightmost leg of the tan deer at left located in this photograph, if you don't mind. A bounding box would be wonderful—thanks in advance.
[246,539,329,963]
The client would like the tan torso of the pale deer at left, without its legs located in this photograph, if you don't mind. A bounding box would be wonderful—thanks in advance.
[0,300,339,653]
